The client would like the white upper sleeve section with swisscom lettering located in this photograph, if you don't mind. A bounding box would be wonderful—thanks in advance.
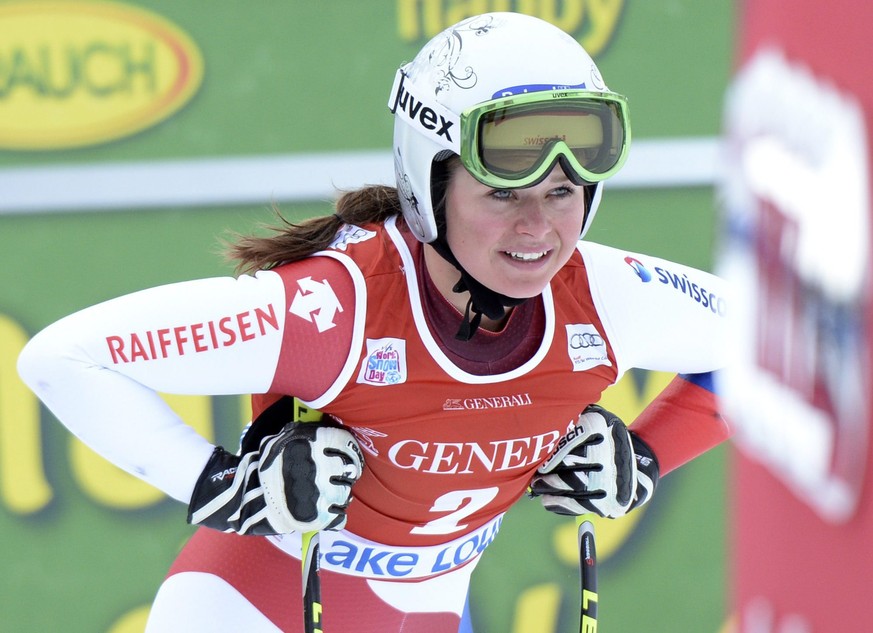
[579,242,730,375]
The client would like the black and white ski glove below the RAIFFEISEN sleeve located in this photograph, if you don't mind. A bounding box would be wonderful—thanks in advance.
[188,422,364,535]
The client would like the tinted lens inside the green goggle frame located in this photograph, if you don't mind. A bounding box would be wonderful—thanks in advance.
[478,99,626,181]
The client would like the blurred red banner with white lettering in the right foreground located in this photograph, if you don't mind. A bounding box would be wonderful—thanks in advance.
[722,0,873,633]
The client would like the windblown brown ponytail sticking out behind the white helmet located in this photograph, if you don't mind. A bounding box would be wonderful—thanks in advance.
[227,185,400,273]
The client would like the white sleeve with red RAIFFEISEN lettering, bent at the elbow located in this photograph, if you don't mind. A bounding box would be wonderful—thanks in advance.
[18,272,285,503]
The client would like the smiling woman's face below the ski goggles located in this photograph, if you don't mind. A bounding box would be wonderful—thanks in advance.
[446,160,585,298]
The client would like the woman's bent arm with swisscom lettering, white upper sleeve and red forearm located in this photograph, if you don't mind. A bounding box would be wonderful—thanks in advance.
[580,243,731,475]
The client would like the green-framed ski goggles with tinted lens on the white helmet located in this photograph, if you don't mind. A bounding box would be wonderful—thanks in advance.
[460,90,630,188]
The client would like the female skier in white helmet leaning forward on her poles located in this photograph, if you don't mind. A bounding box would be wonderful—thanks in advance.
[19,13,727,633]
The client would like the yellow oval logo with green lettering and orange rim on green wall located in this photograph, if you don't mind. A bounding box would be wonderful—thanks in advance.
[0,1,203,150]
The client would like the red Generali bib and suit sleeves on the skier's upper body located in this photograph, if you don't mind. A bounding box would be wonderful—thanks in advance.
[20,215,727,628]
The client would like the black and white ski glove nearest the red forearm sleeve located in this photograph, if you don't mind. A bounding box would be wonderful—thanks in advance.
[531,405,659,519]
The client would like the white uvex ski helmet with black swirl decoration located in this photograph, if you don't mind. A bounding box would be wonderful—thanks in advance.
[388,13,630,243]
